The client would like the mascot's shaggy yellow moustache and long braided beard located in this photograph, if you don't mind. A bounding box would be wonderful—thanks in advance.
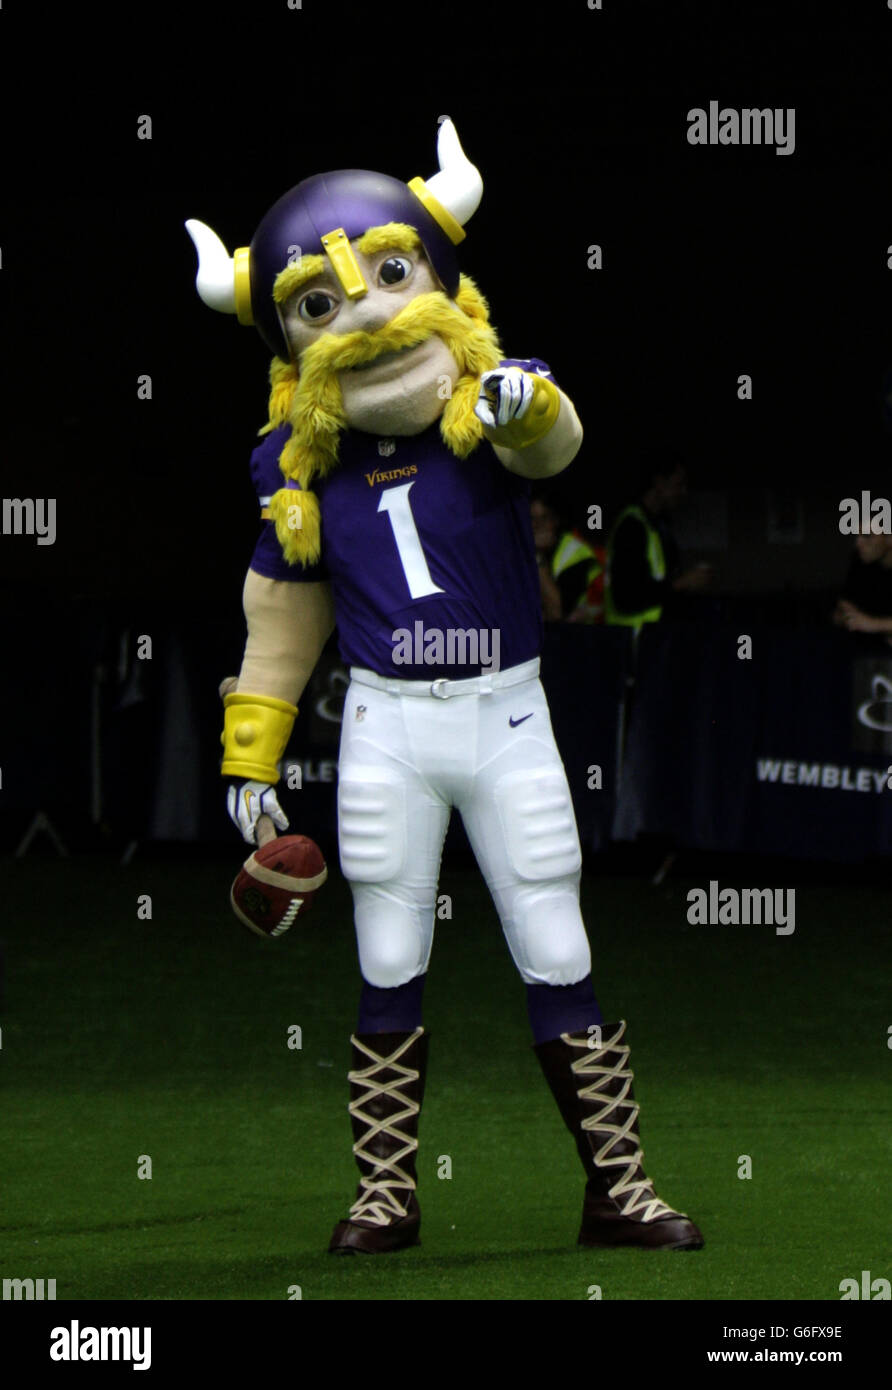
[260,275,502,564]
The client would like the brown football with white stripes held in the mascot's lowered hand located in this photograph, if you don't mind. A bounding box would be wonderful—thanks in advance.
[229,835,328,940]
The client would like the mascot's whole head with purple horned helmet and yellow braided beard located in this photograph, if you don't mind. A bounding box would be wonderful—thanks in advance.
[186,117,502,566]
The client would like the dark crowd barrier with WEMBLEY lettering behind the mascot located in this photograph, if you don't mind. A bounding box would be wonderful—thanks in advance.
[6,602,892,862]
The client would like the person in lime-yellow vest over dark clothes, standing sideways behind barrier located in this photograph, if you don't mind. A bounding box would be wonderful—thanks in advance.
[604,452,713,627]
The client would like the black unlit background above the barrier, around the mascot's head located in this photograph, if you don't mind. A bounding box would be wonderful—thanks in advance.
[0,0,892,612]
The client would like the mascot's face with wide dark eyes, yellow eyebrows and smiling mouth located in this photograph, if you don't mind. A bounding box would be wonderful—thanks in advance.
[281,238,458,435]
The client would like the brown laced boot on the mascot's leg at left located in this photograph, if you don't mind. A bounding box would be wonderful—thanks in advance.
[328,1029,428,1255]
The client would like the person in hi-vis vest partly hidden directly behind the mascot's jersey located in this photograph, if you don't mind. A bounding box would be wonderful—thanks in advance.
[529,492,606,623]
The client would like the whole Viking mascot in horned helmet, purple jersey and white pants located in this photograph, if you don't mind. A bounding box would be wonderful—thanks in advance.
[186,120,703,1254]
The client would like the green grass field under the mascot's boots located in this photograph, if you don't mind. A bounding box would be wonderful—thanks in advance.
[0,847,892,1300]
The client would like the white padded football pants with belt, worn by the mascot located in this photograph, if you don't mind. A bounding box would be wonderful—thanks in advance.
[338,659,592,988]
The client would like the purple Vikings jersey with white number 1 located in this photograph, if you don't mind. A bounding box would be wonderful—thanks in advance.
[251,357,554,680]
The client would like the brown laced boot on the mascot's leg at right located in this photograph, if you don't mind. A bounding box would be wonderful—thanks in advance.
[534,1022,703,1250]
